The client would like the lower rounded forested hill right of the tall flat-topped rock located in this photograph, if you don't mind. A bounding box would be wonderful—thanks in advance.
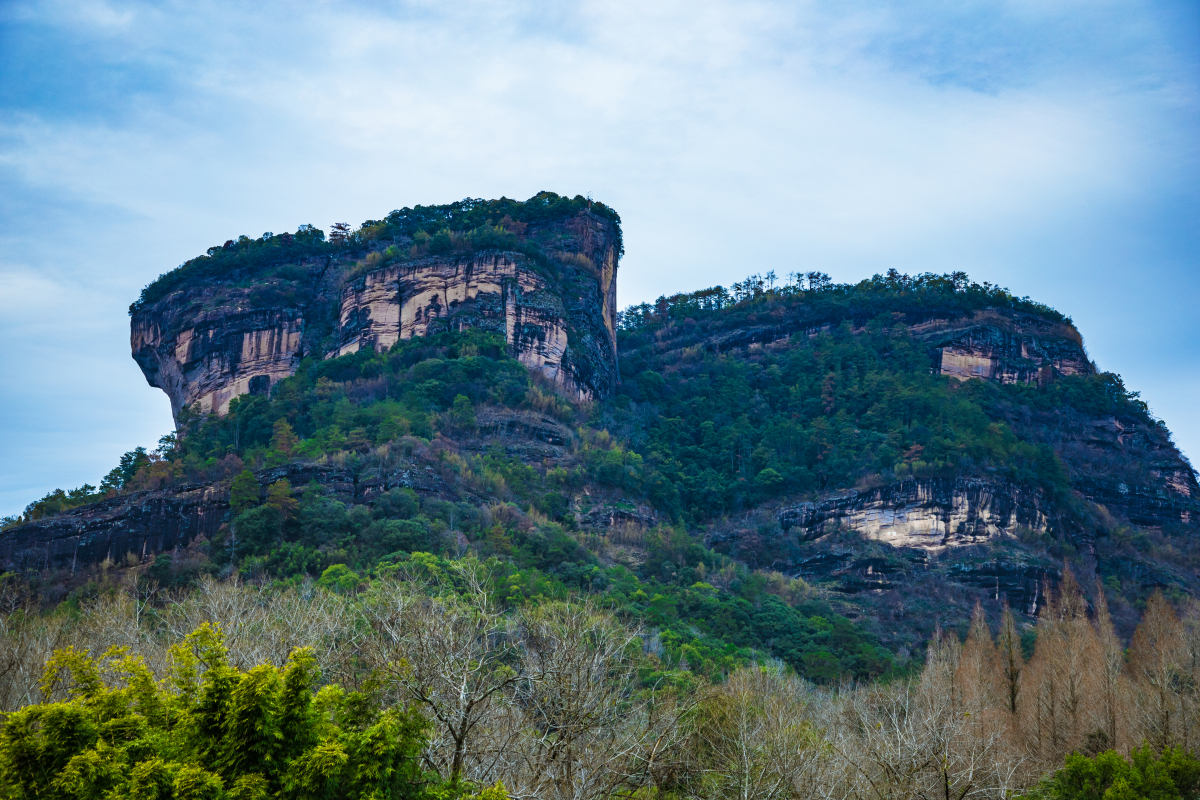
[602,273,1200,644]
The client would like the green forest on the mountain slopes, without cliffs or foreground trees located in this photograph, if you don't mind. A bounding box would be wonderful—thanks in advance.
[8,268,1195,681]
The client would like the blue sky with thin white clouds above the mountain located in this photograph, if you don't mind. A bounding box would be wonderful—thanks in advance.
[0,0,1200,516]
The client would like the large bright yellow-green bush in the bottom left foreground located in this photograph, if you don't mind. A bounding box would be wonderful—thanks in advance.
[0,624,437,800]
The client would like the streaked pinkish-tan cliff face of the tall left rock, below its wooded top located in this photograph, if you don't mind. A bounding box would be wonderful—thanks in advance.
[131,210,619,420]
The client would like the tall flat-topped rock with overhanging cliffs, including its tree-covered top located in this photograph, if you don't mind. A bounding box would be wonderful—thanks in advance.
[131,192,622,420]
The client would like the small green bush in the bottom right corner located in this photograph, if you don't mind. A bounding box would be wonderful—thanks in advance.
[1026,745,1200,800]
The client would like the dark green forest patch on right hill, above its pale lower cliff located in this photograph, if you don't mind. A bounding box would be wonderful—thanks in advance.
[604,318,1066,521]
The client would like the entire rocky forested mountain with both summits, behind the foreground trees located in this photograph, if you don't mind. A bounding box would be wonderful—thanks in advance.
[0,192,1200,680]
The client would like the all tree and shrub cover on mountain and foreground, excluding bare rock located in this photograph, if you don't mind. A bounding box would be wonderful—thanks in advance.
[0,261,1200,800]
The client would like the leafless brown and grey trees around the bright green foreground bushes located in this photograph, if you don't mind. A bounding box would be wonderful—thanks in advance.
[7,568,1200,800]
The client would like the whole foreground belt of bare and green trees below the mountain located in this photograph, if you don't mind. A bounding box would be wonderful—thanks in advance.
[7,561,1200,800]
